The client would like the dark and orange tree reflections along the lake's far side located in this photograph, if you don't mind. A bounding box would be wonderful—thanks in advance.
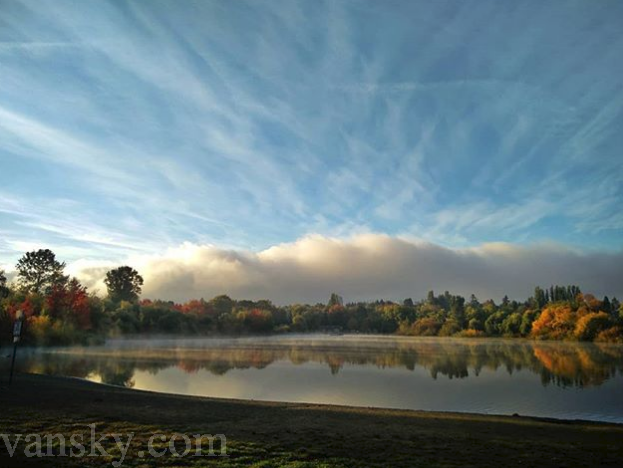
[11,337,623,388]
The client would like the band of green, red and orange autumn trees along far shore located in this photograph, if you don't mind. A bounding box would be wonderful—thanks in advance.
[0,249,623,346]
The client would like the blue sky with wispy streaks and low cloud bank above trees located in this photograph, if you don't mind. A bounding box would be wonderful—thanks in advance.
[0,0,623,302]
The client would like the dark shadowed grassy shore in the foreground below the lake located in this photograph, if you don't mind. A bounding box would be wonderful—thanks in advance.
[0,375,623,468]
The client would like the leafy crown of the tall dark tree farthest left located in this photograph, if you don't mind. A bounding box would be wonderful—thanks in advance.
[16,249,67,293]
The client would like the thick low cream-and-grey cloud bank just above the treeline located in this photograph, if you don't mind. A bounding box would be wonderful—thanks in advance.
[70,234,623,304]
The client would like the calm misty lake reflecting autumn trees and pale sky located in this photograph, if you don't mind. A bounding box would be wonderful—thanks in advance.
[1,335,623,423]
